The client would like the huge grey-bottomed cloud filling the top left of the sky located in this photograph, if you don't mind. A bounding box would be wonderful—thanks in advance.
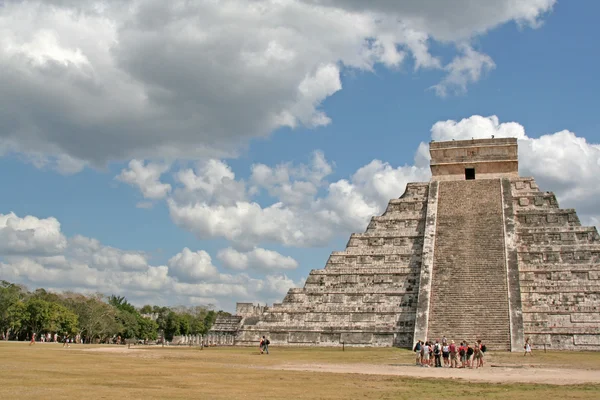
[0,0,555,168]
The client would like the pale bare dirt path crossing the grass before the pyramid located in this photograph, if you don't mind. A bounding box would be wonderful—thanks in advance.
[270,364,600,385]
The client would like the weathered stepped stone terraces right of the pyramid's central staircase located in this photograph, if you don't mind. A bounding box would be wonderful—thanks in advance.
[511,178,600,350]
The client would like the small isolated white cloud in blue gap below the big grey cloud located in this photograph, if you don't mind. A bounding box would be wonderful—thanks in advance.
[116,160,171,199]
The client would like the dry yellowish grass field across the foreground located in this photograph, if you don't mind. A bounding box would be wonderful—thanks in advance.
[0,343,600,400]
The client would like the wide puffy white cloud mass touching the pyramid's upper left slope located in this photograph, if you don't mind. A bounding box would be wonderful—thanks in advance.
[167,152,428,251]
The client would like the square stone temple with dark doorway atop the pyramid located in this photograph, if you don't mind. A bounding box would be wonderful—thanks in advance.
[429,138,519,181]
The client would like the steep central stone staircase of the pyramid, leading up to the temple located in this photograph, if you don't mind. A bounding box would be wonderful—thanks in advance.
[426,179,510,350]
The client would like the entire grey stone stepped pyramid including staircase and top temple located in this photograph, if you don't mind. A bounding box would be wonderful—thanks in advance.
[230,138,600,351]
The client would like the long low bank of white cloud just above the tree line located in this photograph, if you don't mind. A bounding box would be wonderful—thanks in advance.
[0,214,301,311]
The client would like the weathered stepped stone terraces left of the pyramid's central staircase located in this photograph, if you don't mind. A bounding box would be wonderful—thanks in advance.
[236,183,429,347]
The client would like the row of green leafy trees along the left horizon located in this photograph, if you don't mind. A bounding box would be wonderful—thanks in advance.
[0,280,230,343]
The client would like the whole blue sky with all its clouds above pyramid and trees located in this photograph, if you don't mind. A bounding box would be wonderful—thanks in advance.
[0,0,600,310]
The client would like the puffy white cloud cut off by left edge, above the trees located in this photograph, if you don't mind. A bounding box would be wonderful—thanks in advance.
[0,212,67,255]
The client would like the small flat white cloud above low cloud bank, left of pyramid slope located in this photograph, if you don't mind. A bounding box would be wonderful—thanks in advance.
[217,247,298,271]
